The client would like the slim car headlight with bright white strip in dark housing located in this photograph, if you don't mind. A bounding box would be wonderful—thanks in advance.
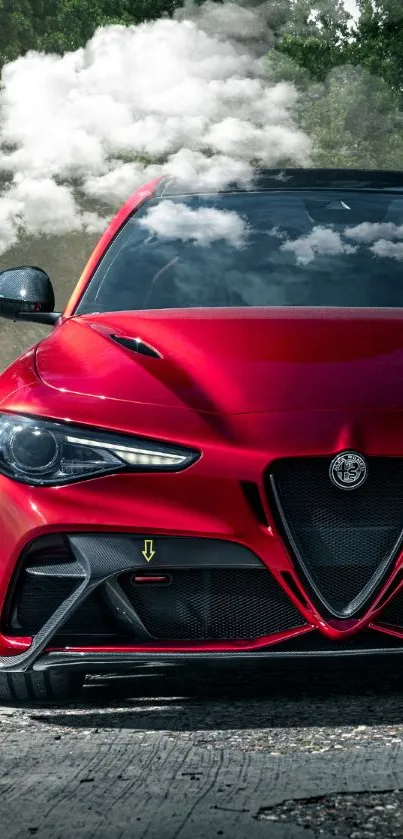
[0,414,199,486]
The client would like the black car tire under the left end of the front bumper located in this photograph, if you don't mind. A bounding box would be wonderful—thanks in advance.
[0,670,85,705]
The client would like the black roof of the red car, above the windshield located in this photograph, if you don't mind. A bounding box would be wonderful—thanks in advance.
[154,168,403,198]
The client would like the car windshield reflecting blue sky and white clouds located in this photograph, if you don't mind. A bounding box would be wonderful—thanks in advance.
[76,190,403,314]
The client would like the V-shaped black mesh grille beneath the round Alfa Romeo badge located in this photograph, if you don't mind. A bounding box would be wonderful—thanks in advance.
[267,457,403,615]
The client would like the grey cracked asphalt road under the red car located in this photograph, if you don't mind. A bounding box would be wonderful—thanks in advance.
[0,660,403,839]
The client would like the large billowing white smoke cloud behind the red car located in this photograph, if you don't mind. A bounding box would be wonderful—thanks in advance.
[0,3,311,253]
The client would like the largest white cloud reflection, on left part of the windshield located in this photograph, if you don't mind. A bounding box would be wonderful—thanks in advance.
[138,200,247,248]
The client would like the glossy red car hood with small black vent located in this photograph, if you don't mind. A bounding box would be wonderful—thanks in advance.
[36,308,403,414]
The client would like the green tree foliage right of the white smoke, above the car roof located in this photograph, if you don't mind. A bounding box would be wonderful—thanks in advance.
[267,0,403,169]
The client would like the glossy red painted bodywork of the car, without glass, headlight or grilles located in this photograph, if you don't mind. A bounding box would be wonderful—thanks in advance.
[0,179,403,668]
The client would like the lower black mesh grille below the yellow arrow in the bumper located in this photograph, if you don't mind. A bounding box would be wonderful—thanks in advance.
[119,569,305,641]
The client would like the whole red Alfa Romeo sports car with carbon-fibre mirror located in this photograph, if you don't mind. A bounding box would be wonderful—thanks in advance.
[0,169,403,701]
